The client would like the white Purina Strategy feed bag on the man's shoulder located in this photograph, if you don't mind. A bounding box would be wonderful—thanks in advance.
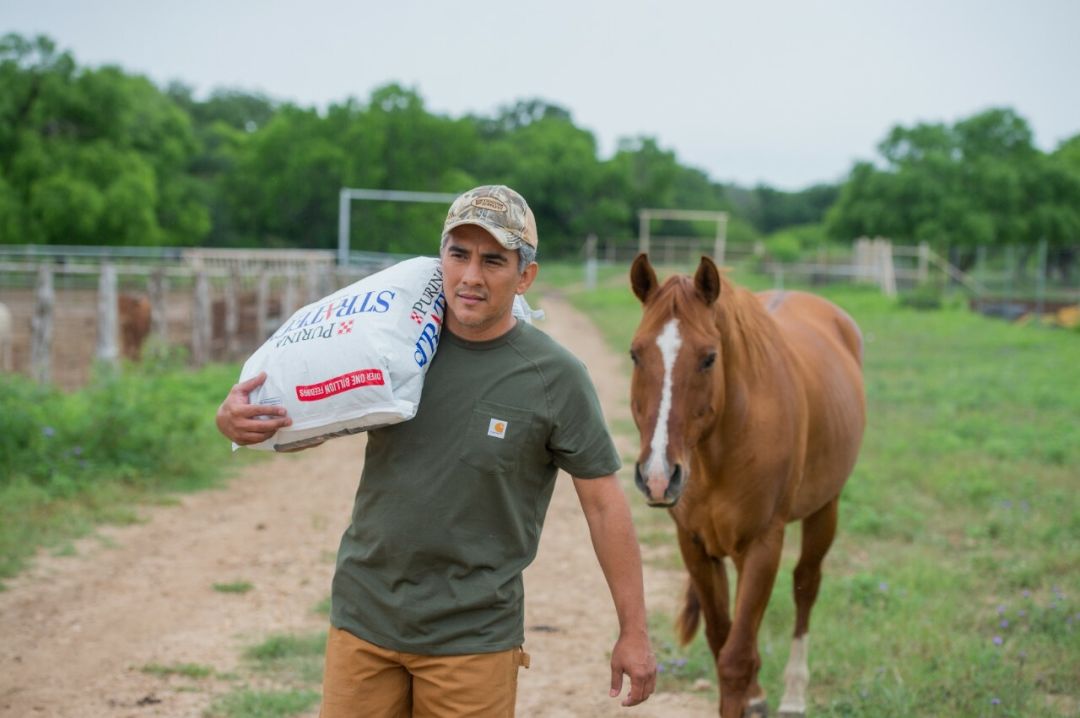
[240,257,446,451]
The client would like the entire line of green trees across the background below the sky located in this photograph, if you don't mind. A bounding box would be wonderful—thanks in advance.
[0,35,1080,265]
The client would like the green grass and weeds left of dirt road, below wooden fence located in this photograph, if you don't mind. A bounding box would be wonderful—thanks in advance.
[0,356,267,587]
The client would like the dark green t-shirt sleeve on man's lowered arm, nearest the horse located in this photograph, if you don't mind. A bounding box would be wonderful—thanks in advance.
[548,356,622,478]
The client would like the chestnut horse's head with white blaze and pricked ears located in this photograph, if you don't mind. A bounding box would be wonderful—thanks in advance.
[630,254,724,506]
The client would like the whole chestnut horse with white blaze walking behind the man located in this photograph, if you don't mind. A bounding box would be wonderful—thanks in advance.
[630,254,866,718]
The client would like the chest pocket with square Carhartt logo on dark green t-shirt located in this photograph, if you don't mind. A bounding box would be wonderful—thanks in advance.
[459,401,534,474]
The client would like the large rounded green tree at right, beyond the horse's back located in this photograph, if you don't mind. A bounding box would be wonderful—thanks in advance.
[826,108,1075,269]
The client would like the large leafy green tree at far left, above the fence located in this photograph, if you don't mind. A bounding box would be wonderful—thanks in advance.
[0,35,210,244]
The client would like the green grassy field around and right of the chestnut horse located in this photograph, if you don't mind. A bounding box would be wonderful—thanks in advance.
[533,260,1080,718]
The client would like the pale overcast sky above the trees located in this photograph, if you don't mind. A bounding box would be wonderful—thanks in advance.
[8,0,1080,189]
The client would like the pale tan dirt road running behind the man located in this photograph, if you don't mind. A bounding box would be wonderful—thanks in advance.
[0,296,715,718]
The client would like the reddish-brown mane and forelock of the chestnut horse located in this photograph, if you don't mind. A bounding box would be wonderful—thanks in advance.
[656,267,781,371]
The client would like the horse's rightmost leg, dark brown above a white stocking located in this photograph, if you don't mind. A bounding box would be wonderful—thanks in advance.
[780,500,838,718]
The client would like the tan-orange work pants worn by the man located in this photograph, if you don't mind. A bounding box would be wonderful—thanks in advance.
[319,626,529,718]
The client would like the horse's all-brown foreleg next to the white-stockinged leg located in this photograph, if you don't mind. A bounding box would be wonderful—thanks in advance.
[717,521,784,718]
